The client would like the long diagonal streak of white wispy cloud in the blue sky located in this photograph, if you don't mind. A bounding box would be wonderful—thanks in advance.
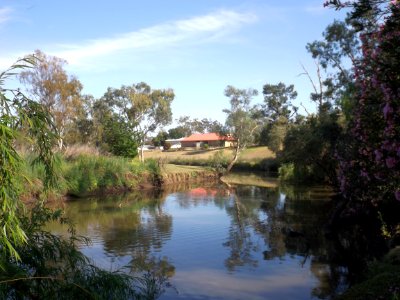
[52,10,257,65]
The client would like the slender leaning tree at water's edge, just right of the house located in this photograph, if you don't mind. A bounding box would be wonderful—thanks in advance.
[223,85,260,172]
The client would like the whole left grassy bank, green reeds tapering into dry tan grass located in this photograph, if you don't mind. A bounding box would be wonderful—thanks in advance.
[18,154,220,202]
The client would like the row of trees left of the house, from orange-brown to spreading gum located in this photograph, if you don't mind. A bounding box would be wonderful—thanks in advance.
[19,50,175,160]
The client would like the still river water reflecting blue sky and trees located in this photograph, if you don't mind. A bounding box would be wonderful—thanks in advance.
[52,175,347,299]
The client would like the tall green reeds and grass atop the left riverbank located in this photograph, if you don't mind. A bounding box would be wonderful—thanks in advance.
[18,154,160,200]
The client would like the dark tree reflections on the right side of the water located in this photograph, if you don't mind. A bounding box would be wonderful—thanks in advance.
[224,182,347,299]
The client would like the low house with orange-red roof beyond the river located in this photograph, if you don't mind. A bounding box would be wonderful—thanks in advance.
[180,132,236,148]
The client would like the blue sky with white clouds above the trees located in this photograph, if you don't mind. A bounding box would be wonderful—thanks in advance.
[0,0,343,122]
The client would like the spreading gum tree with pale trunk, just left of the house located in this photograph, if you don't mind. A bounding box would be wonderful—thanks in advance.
[102,82,175,162]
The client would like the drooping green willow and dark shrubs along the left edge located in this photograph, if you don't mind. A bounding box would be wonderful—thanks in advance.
[0,57,167,299]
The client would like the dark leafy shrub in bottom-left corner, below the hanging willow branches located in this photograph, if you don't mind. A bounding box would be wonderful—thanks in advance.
[0,204,162,299]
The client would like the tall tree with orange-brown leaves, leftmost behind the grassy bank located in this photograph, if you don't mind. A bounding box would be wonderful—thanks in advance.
[20,50,83,149]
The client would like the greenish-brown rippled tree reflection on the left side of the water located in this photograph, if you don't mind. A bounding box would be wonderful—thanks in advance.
[57,190,175,278]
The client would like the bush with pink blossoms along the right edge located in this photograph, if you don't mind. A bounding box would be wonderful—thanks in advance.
[337,1,400,237]
